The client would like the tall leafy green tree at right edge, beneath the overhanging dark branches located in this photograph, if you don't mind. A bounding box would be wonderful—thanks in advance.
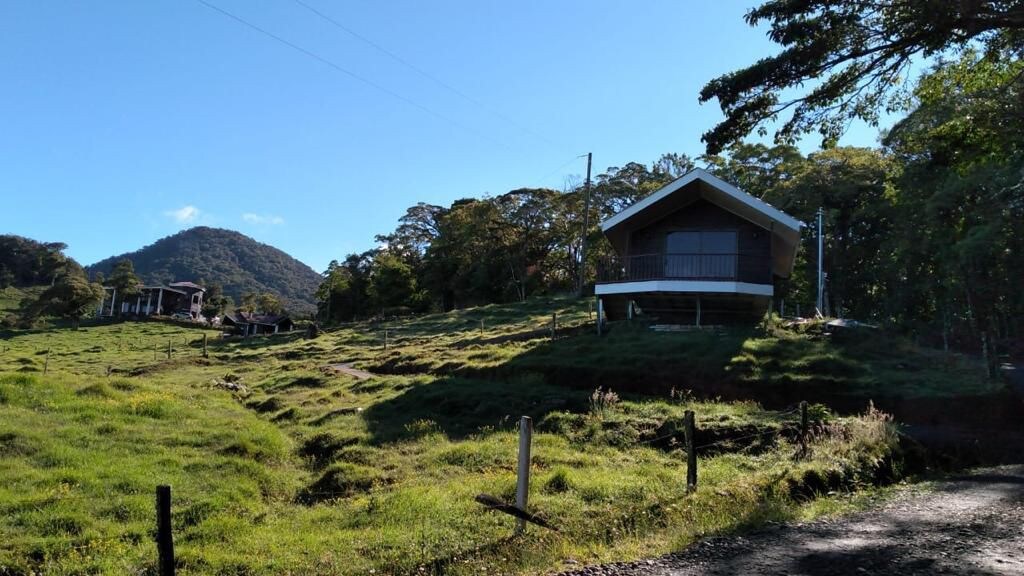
[886,51,1024,375]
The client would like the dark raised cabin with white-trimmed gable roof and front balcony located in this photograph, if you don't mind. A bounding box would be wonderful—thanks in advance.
[594,168,804,326]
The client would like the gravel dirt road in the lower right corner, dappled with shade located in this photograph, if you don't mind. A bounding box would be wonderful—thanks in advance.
[566,465,1024,576]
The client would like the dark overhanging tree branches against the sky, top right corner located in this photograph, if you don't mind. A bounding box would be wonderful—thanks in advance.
[699,0,1024,154]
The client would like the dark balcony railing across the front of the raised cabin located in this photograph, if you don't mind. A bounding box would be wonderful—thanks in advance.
[597,253,771,284]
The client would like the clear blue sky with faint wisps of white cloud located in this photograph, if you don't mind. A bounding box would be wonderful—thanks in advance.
[0,0,892,271]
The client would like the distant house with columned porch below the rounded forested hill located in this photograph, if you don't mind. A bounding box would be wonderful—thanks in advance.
[98,282,206,320]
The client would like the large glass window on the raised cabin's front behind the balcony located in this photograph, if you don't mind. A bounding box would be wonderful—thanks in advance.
[665,230,737,279]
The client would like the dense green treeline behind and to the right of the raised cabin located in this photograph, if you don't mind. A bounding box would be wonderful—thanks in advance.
[317,51,1024,366]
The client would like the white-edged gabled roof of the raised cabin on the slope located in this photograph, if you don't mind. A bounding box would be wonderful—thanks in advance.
[601,168,804,278]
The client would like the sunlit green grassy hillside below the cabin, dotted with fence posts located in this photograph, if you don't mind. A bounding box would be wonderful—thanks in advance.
[0,299,958,574]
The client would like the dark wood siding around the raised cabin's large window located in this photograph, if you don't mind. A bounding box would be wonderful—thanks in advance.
[628,200,772,284]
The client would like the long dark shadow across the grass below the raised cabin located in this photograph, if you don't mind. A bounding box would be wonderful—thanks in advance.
[364,325,749,443]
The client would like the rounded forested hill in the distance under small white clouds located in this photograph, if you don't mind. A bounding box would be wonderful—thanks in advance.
[86,227,322,314]
